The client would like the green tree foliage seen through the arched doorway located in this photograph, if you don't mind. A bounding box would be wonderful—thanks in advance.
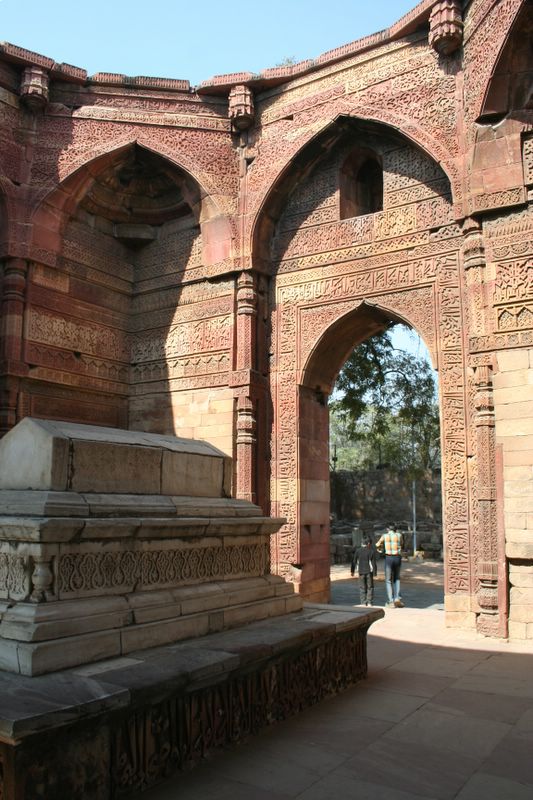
[330,329,440,477]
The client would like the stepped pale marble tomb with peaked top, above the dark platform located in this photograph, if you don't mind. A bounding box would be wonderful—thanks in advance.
[0,419,302,675]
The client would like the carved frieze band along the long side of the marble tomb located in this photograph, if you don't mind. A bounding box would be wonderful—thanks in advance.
[57,544,269,597]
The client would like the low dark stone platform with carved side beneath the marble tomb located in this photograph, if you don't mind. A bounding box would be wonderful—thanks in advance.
[0,605,383,800]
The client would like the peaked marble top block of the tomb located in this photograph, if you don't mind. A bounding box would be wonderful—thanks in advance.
[0,417,231,497]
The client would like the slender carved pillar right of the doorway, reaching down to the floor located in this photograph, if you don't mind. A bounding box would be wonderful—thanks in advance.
[474,364,505,636]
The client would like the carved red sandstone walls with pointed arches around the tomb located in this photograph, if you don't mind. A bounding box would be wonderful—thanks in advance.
[0,0,533,636]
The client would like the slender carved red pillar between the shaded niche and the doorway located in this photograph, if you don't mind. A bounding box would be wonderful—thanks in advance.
[232,272,257,502]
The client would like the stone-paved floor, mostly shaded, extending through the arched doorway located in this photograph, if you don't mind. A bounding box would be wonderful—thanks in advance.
[132,562,533,800]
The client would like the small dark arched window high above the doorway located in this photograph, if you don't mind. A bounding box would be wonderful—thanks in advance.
[339,148,383,219]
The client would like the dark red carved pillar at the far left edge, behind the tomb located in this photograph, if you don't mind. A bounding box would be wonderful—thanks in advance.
[0,258,28,434]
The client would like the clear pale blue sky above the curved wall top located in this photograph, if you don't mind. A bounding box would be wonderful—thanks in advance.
[0,0,417,85]
